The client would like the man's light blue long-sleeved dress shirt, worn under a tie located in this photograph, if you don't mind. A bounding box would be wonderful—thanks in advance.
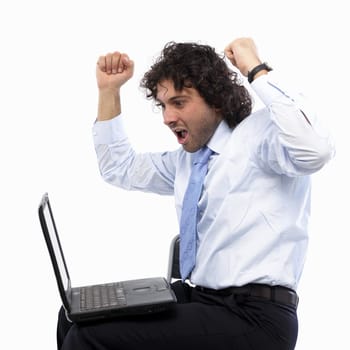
[93,73,334,290]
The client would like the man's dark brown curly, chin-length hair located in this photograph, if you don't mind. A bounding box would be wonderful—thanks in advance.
[140,41,252,128]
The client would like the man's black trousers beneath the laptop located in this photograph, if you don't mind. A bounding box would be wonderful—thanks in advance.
[57,282,298,350]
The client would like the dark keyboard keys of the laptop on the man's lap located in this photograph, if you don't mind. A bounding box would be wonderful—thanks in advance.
[80,282,126,311]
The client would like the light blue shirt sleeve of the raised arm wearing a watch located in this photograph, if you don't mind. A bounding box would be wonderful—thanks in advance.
[252,75,335,176]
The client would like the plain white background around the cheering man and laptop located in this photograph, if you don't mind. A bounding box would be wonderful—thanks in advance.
[0,0,350,350]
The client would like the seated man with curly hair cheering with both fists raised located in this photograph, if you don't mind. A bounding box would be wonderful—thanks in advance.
[58,38,333,350]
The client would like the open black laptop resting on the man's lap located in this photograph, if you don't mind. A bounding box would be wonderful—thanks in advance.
[39,193,176,323]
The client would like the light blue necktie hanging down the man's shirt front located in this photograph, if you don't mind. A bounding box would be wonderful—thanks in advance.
[180,146,213,281]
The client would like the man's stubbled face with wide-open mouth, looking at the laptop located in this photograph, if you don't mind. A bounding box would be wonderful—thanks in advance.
[157,80,222,152]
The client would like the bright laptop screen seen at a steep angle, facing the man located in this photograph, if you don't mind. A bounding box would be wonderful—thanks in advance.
[43,200,70,291]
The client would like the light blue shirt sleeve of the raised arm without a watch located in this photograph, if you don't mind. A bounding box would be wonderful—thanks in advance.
[92,116,178,195]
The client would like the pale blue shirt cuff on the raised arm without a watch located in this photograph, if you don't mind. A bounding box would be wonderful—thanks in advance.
[92,115,127,145]
